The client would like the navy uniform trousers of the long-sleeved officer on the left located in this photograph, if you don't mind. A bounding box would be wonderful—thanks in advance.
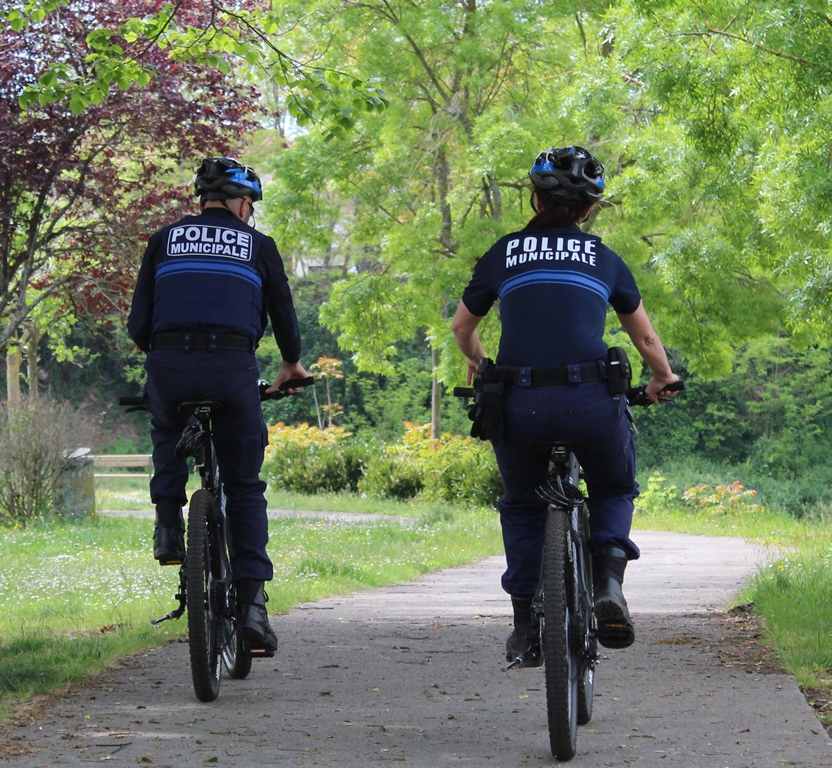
[145,349,273,581]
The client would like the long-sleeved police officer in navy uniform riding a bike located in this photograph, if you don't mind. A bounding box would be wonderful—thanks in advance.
[127,157,308,652]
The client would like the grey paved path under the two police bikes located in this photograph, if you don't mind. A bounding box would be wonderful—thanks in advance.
[0,532,832,768]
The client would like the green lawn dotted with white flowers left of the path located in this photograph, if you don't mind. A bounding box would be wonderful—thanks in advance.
[0,478,501,718]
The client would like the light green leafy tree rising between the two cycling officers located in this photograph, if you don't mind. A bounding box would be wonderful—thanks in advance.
[264,0,580,435]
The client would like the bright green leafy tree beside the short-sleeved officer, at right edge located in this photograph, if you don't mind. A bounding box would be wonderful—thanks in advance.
[556,0,832,376]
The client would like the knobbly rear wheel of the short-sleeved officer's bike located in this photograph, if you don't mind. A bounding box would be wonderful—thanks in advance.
[543,507,579,760]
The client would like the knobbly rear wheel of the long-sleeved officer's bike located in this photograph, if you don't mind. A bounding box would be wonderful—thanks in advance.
[185,489,222,701]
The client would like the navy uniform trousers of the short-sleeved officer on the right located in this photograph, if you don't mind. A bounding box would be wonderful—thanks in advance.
[494,381,639,597]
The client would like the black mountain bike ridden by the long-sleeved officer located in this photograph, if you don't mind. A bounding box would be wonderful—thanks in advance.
[119,377,314,701]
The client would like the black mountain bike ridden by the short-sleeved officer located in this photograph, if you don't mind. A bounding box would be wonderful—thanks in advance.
[454,381,684,761]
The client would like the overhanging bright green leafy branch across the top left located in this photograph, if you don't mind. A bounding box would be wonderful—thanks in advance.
[6,0,385,136]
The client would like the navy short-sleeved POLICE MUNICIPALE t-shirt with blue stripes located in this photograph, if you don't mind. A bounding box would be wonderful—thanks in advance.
[462,226,641,367]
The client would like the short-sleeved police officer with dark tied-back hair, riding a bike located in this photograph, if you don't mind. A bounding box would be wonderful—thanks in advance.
[453,147,678,661]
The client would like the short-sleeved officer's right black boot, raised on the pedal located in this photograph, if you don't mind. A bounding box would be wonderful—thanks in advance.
[592,547,635,648]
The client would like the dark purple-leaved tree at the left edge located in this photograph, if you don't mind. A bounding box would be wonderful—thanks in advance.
[0,0,255,392]
